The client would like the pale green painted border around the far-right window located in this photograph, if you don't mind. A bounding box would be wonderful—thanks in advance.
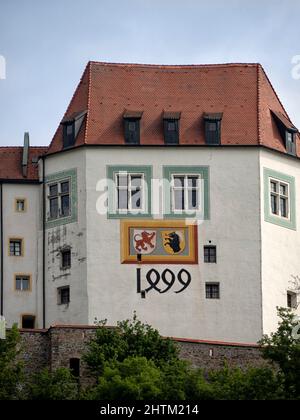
[264,168,296,230]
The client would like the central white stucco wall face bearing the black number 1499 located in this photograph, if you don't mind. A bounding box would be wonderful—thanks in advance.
[83,147,262,342]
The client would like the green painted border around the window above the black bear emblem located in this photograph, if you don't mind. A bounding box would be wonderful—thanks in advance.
[163,166,210,220]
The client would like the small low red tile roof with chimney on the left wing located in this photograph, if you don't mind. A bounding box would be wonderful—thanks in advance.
[0,147,48,181]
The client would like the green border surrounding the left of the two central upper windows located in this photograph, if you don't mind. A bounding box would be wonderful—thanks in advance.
[106,165,153,219]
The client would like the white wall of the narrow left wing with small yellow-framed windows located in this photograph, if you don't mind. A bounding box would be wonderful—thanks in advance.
[3,184,42,328]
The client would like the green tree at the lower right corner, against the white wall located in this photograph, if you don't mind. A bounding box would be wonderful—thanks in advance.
[260,308,300,399]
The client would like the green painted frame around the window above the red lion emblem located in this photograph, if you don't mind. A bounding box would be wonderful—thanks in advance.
[106,165,153,219]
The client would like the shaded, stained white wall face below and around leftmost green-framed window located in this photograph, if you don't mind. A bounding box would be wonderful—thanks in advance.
[45,150,88,327]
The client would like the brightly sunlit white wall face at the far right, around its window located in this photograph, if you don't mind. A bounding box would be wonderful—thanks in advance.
[260,150,300,334]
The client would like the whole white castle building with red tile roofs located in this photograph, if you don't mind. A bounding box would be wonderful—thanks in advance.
[0,62,300,343]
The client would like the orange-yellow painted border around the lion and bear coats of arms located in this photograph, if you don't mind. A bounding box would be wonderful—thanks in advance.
[121,220,198,264]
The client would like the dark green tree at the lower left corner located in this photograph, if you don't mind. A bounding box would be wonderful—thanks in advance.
[0,326,24,400]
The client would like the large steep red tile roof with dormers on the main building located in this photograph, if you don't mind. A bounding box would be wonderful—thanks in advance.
[48,62,300,153]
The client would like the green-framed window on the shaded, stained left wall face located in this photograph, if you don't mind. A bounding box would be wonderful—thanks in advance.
[45,169,78,229]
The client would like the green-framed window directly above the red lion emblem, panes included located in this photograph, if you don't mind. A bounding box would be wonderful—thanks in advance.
[107,165,152,219]
